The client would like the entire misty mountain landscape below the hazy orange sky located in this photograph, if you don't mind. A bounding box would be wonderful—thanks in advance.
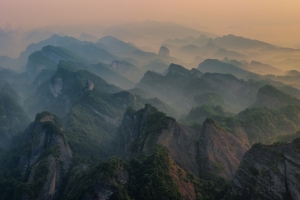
[0,21,300,200]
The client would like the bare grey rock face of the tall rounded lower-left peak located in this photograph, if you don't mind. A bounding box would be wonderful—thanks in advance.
[19,112,72,200]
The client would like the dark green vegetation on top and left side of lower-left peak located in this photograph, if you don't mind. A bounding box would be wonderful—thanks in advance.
[0,112,66,200]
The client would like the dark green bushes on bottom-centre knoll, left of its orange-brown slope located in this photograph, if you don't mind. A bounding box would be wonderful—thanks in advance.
[128,146,182,200]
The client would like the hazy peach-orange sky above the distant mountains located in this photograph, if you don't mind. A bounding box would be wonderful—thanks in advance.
[0,0,300,46]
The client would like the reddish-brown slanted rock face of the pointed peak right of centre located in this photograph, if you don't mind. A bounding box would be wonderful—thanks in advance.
[198,119,248,179]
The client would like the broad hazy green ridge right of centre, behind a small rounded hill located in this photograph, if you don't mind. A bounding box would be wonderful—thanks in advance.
[136,64,261,113]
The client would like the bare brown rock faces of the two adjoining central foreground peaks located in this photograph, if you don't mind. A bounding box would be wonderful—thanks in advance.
[119,105,248,179]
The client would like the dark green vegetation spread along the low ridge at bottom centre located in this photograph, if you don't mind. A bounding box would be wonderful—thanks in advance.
[63,146,230,200]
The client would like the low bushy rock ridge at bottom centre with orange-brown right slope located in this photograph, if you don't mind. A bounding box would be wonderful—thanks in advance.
[63,146,202,200]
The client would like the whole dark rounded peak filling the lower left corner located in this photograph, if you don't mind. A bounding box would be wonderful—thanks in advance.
[0,112,72,199]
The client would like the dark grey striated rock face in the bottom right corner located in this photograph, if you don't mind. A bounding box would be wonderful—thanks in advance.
[233,139,300,200]
